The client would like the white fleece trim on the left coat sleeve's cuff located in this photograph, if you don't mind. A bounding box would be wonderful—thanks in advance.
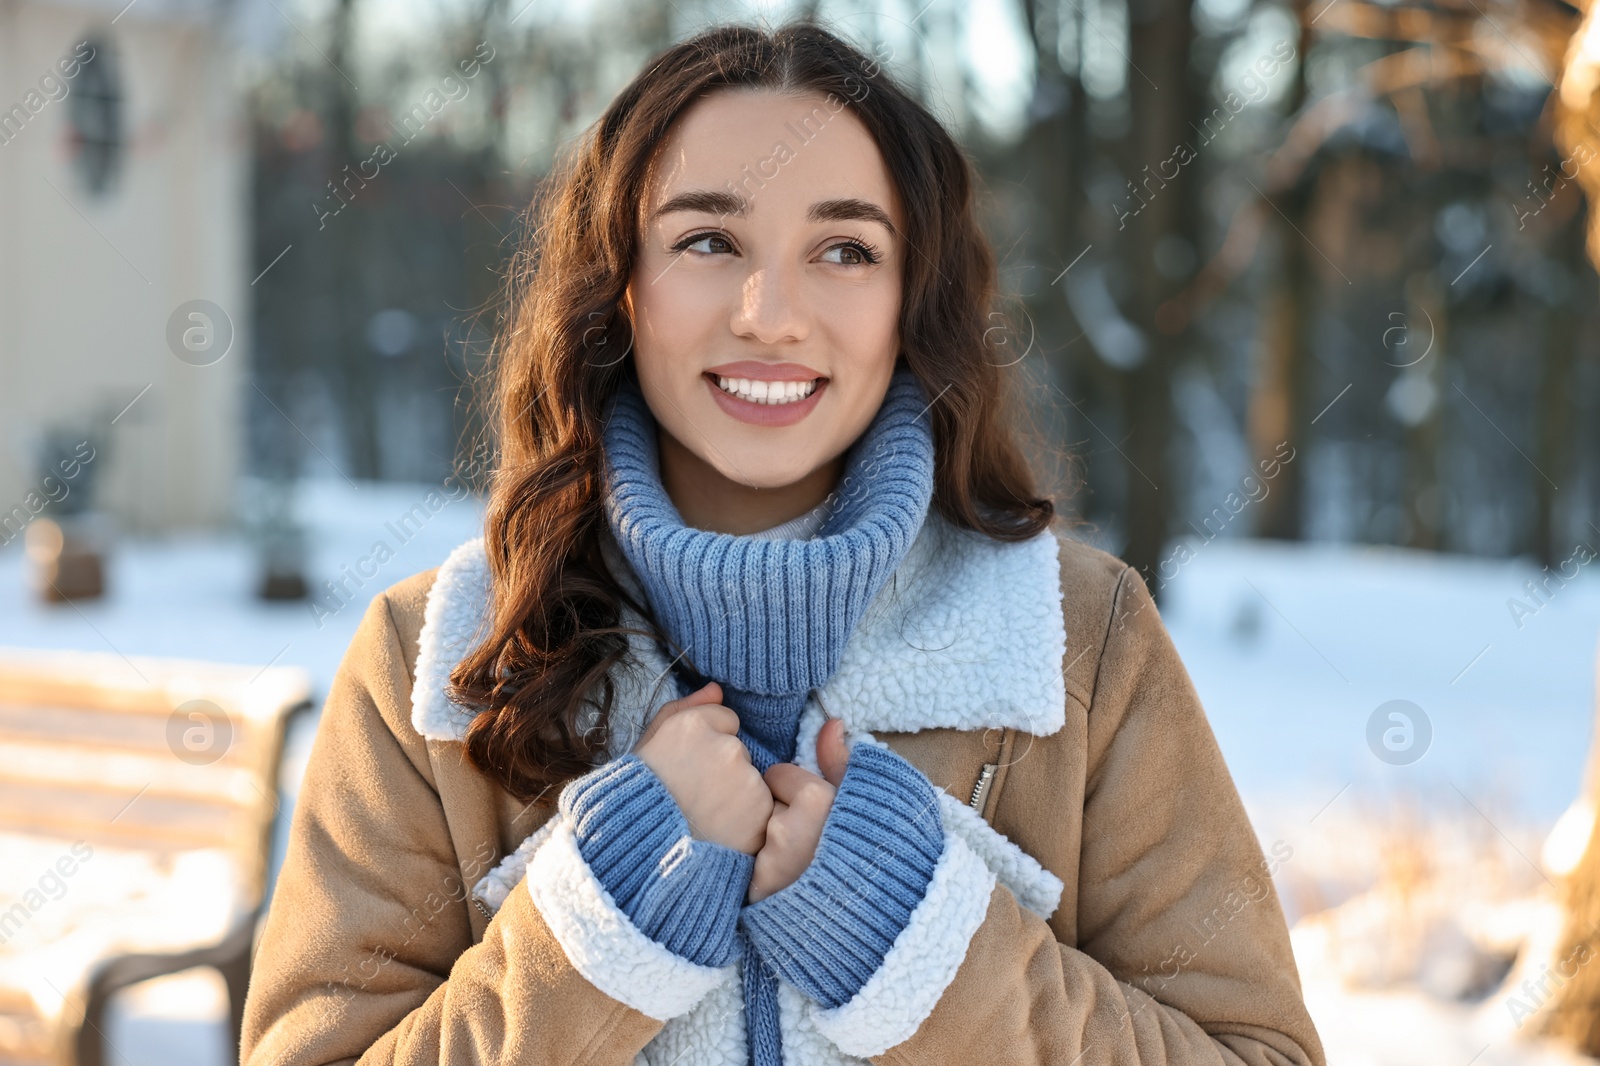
[526,818,738,1021]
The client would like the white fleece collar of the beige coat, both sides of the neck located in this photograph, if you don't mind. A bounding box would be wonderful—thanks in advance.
[411,511,1066,742]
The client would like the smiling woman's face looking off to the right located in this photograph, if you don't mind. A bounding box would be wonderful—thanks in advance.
[626,90,904,525]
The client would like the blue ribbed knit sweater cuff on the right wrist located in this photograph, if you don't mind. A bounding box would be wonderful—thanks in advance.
[739,744,944,1007]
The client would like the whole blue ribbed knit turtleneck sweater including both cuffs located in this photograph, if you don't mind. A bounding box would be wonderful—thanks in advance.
[560,370,944,1066]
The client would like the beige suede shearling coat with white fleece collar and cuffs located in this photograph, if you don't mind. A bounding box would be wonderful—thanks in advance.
[242,512,1325,1066]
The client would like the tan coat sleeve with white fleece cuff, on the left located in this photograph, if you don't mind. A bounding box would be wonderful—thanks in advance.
[240,595,725,1066]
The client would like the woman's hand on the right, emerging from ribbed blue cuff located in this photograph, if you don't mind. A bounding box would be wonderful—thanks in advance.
[747,719,850,903]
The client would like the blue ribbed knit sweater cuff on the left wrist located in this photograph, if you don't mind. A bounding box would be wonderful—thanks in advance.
[558,752,755,967]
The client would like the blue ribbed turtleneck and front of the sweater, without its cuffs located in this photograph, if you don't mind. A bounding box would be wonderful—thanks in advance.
[603,367,933,1066]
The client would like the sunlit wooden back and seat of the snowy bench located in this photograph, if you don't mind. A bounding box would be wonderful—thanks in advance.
[0,648,312,1066]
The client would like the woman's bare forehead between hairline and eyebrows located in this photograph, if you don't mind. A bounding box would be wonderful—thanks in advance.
[642,90,902,226]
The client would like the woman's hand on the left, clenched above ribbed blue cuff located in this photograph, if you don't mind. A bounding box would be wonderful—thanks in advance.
[634,682,774,855]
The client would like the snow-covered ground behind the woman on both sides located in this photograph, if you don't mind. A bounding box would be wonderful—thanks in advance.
[0,482,1600,1066]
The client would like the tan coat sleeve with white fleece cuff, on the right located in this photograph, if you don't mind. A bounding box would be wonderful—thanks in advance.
[800,568,1325,1066]
